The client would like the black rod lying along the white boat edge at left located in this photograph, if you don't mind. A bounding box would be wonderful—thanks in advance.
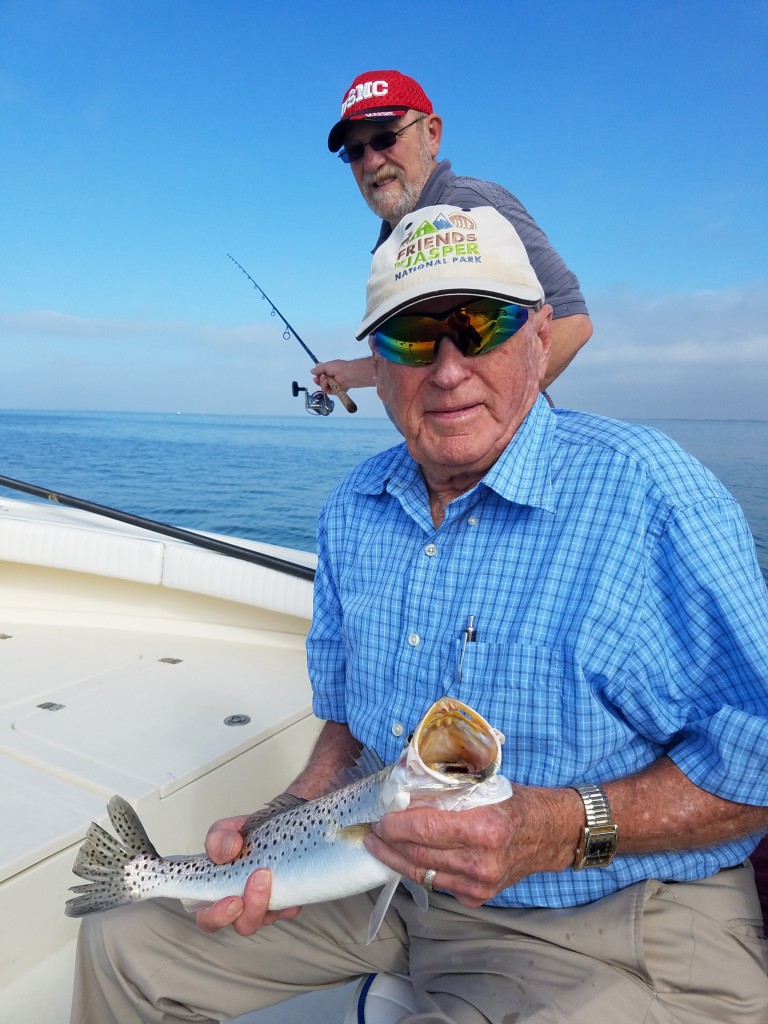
[0,476,314,583]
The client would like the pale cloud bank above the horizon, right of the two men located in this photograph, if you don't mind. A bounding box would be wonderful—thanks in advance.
[551,284,768,419]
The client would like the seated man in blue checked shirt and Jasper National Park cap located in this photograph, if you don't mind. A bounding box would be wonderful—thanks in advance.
[73,206,768,1024]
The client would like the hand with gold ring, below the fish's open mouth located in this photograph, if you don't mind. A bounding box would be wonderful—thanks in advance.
[366,786,583,906]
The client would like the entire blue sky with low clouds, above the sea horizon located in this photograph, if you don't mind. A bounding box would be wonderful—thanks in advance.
[0,0,768,419]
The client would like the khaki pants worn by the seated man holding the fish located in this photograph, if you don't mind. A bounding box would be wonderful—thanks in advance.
[72,865,768,1024]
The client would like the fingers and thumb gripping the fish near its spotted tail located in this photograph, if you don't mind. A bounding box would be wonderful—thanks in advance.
[198,814,301,935]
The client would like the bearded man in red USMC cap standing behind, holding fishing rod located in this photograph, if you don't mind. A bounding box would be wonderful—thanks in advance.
[314,71,592,391]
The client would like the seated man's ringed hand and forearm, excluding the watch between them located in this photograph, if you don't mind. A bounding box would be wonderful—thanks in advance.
[365,756,768,906]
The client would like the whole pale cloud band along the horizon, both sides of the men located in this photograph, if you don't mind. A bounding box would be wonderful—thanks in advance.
[0,284,768,420]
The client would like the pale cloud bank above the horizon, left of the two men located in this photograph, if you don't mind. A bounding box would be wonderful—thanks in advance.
[0,310,383,416]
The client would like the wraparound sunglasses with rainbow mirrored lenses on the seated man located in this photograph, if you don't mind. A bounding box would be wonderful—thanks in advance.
[371,299,539,367]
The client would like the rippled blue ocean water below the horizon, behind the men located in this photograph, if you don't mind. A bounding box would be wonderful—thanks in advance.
[0,412,768,580]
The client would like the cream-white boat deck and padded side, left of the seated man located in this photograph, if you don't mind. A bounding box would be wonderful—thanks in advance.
[0,500,318,1024]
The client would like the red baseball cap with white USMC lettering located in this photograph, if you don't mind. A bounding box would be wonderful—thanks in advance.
[328,71,432,153]
